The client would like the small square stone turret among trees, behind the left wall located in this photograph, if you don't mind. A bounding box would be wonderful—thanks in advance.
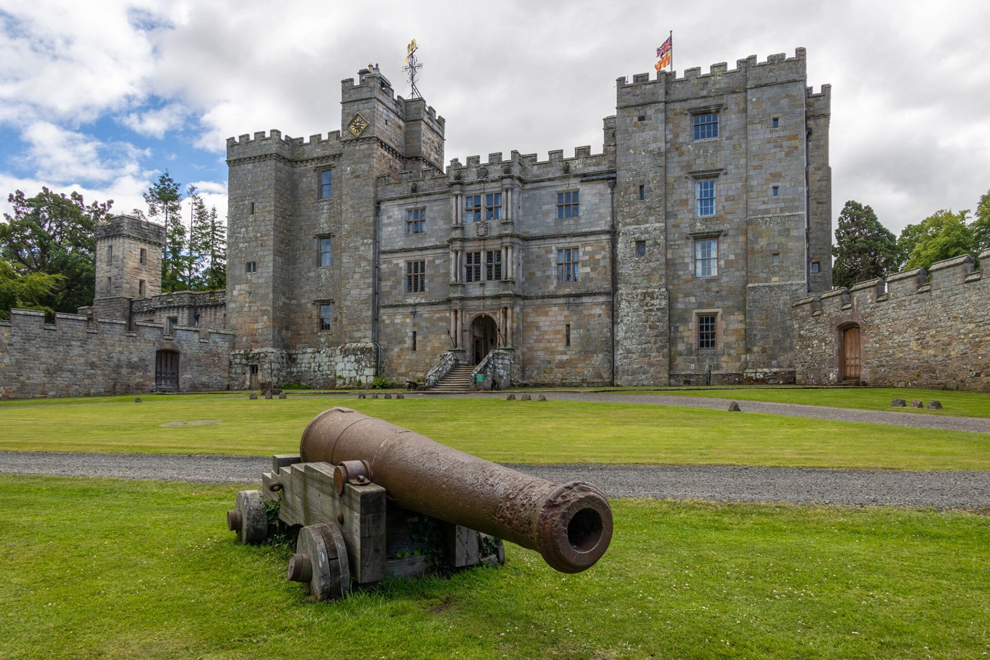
[93,215,165,321]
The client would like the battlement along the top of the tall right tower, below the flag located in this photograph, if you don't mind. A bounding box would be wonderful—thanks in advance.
[616,48,807,108]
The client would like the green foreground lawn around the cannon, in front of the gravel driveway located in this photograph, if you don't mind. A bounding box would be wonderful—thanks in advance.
[0,475,990,660]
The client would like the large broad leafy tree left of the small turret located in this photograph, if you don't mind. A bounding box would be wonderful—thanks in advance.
[0,188,113,312]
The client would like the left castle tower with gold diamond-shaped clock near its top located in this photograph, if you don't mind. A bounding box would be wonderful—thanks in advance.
[227,66,444,386]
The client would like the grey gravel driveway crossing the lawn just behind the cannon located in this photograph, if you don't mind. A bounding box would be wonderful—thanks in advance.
[0,452,990,508]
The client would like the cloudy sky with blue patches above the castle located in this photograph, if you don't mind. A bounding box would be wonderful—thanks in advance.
[0,0,990,237]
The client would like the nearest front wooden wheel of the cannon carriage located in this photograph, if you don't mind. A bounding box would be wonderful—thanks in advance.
[285,523,351,600]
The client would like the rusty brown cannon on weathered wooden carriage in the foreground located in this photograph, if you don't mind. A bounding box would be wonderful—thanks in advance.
[227,408,612,599]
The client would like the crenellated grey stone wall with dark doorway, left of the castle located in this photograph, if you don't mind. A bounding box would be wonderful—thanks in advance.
[0,309,233,398]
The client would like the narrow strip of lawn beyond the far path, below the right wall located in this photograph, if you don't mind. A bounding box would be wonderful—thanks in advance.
[648,387,990,417]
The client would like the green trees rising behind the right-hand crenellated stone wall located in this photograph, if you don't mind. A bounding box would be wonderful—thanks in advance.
[832,191,990,287]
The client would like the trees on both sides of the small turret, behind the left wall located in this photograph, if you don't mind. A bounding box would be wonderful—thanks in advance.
[0,170,227,319]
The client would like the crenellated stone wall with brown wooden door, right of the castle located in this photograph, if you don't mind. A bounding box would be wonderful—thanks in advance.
[793,250,990,392]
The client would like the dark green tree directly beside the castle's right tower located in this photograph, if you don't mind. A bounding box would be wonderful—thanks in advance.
[832,200,901,287]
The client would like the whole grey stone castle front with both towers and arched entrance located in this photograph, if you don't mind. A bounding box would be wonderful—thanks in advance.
[227,54,831,386]
